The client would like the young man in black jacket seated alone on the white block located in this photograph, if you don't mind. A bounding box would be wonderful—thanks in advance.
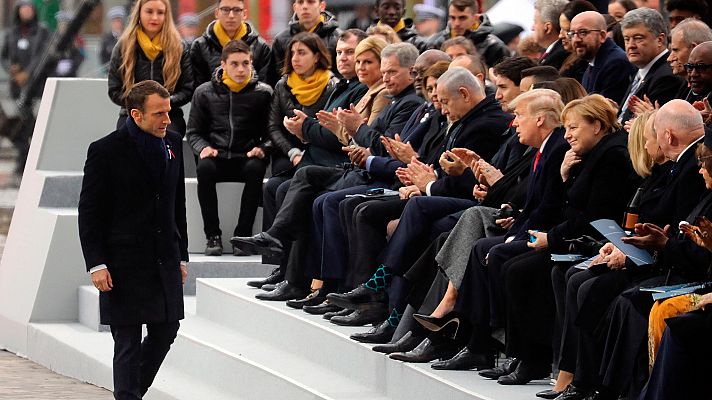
[187,41,272,256]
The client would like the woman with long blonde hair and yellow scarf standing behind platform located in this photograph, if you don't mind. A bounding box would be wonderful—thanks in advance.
[109,0,193,136]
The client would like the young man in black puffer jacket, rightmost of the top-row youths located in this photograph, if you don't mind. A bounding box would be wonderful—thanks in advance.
[426,0,510,69]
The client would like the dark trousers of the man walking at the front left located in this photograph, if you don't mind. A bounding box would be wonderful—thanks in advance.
[111,321,180,400]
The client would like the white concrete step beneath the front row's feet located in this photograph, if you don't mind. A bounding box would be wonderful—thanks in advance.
[196,279,550,400]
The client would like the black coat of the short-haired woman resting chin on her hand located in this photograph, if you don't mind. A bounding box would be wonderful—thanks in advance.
[547,132,639,253]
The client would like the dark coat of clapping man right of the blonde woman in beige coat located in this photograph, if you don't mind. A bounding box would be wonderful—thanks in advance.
[354,86,424,156]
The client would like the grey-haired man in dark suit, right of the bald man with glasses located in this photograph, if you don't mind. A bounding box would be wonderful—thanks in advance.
[618,8,683,123]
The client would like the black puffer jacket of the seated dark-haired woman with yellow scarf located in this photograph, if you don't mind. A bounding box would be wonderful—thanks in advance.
[267,75,339,155]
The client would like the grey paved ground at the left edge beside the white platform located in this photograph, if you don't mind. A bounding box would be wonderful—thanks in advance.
[0,140,113,400]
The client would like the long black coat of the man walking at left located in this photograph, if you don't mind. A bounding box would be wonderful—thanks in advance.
[79,127,188,325]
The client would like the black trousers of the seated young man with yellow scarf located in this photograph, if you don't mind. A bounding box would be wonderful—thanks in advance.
[197,157,267,237]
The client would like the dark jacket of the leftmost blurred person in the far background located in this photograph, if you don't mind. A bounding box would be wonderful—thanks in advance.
[0,3,50,99]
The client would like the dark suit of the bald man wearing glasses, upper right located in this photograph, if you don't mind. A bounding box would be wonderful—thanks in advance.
[581,39,636,104]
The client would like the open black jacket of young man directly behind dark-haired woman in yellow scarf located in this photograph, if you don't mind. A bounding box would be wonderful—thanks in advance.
[267,11,341,85]
